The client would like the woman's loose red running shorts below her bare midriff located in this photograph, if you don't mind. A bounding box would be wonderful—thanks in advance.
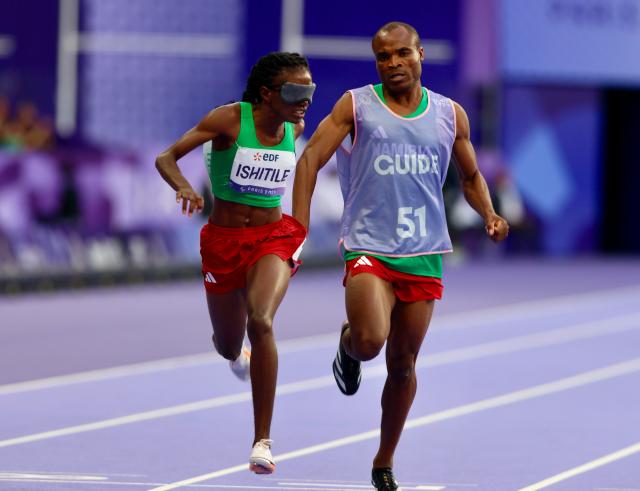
[200,214,307,294]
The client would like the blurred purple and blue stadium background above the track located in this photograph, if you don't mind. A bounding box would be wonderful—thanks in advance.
[0,0,640,294]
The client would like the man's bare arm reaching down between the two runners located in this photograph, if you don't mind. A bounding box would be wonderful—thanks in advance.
[292,92,353,228]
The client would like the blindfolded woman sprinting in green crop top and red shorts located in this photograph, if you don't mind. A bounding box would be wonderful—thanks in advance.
[156,52,315,474]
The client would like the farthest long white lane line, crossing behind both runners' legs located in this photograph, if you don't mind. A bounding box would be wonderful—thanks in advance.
[0,286,640,395]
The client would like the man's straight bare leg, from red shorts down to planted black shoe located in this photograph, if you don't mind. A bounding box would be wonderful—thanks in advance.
[373,300,434,468]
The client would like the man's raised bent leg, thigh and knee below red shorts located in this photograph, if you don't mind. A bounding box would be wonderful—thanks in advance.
[342,273,396,361]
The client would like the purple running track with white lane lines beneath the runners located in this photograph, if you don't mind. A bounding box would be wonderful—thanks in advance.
[0,258,640,491]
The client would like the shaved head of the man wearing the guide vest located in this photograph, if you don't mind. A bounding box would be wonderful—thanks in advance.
[372,27,424,93]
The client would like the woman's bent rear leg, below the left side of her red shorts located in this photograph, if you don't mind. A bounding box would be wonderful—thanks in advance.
[207,290,247,360]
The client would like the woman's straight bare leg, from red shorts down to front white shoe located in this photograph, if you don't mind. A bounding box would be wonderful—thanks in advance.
[247,254,291,443]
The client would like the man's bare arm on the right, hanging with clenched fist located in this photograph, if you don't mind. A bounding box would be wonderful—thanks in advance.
[453,102,509,242]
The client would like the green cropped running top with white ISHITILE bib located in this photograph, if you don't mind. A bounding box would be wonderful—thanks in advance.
[203,102,296,208]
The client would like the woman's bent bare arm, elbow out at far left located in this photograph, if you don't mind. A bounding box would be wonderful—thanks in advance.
[156,104,240,216]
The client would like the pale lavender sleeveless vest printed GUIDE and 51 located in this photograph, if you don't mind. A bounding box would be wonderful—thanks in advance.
[338,85,455,257]
